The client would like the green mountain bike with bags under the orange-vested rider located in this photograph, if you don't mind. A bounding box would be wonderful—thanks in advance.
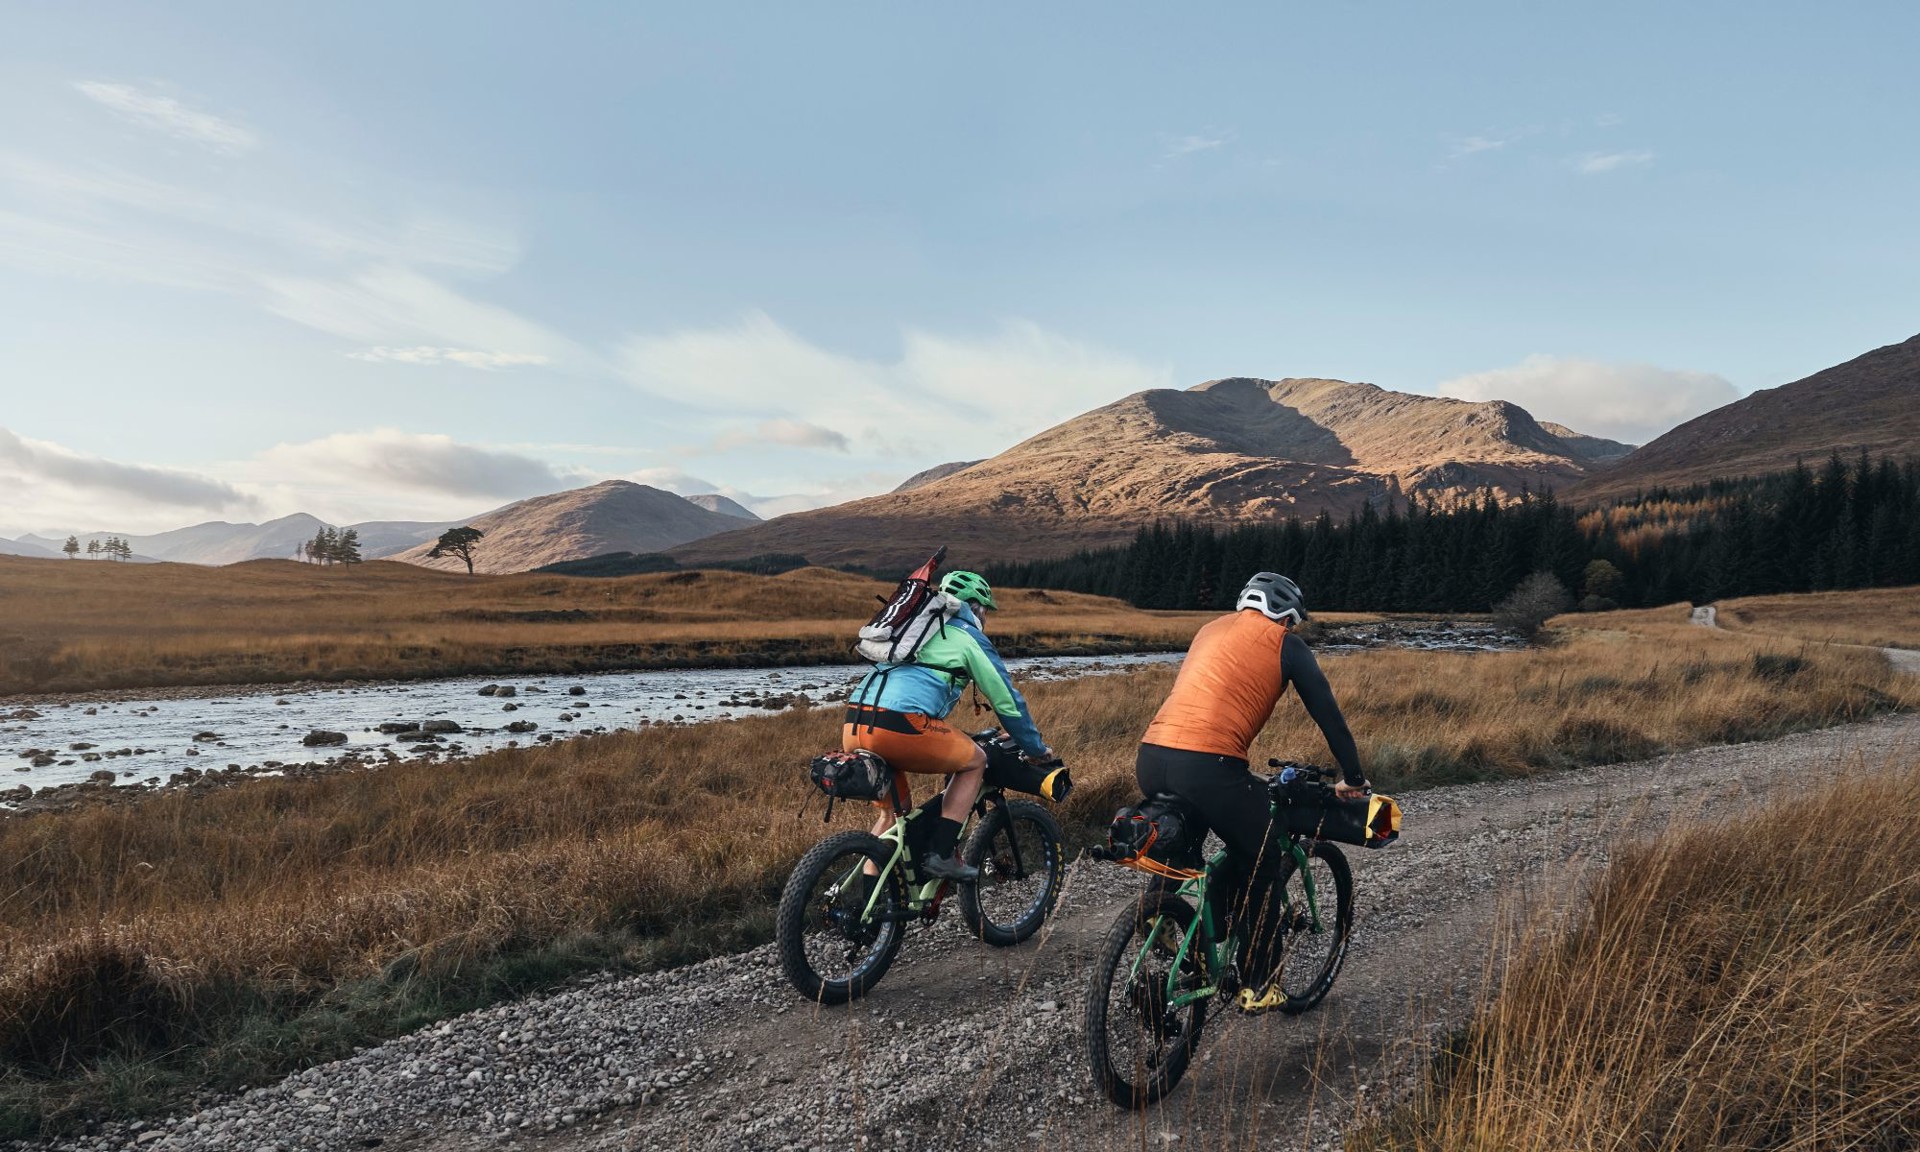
[1085,760,1400,1108]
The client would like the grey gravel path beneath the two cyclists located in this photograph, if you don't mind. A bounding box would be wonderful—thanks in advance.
[33,716,1920,1152]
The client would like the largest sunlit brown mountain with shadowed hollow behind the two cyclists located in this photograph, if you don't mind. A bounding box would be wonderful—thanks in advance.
[672,376,1630,570]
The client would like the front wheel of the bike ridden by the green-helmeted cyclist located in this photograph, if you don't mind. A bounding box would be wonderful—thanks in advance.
[960,801,1068,948]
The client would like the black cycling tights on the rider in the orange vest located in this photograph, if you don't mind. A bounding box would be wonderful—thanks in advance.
[1133,743,1284,987]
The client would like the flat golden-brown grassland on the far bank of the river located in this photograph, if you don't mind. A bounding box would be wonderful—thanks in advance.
[0,557,1210,695]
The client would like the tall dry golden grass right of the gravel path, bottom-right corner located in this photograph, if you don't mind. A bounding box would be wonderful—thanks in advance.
[1348,760,1920,1152]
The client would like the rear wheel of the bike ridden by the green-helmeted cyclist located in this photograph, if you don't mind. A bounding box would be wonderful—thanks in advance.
[774,831,906,1004]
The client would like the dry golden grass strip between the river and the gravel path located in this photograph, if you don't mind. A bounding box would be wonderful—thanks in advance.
[0,609,1920,1131]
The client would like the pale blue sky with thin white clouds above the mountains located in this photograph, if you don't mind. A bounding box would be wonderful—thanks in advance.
[0,0,1920,536]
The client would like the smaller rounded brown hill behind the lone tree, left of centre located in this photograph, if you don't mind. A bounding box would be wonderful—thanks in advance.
[392,480,739,572]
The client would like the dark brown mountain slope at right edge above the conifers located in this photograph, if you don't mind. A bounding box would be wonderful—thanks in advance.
[1569,328,1920,501]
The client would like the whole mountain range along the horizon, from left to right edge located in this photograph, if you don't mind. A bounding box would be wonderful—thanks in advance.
[0,336,1920,572]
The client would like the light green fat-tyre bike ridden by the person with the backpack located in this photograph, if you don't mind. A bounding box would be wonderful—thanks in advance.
[774,730,1066,1004]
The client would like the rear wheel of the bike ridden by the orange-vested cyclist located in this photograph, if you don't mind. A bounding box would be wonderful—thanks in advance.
[1085,889,1208,1108]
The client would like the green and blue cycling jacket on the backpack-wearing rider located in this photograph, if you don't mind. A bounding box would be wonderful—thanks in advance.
[847,605,1046,756]
